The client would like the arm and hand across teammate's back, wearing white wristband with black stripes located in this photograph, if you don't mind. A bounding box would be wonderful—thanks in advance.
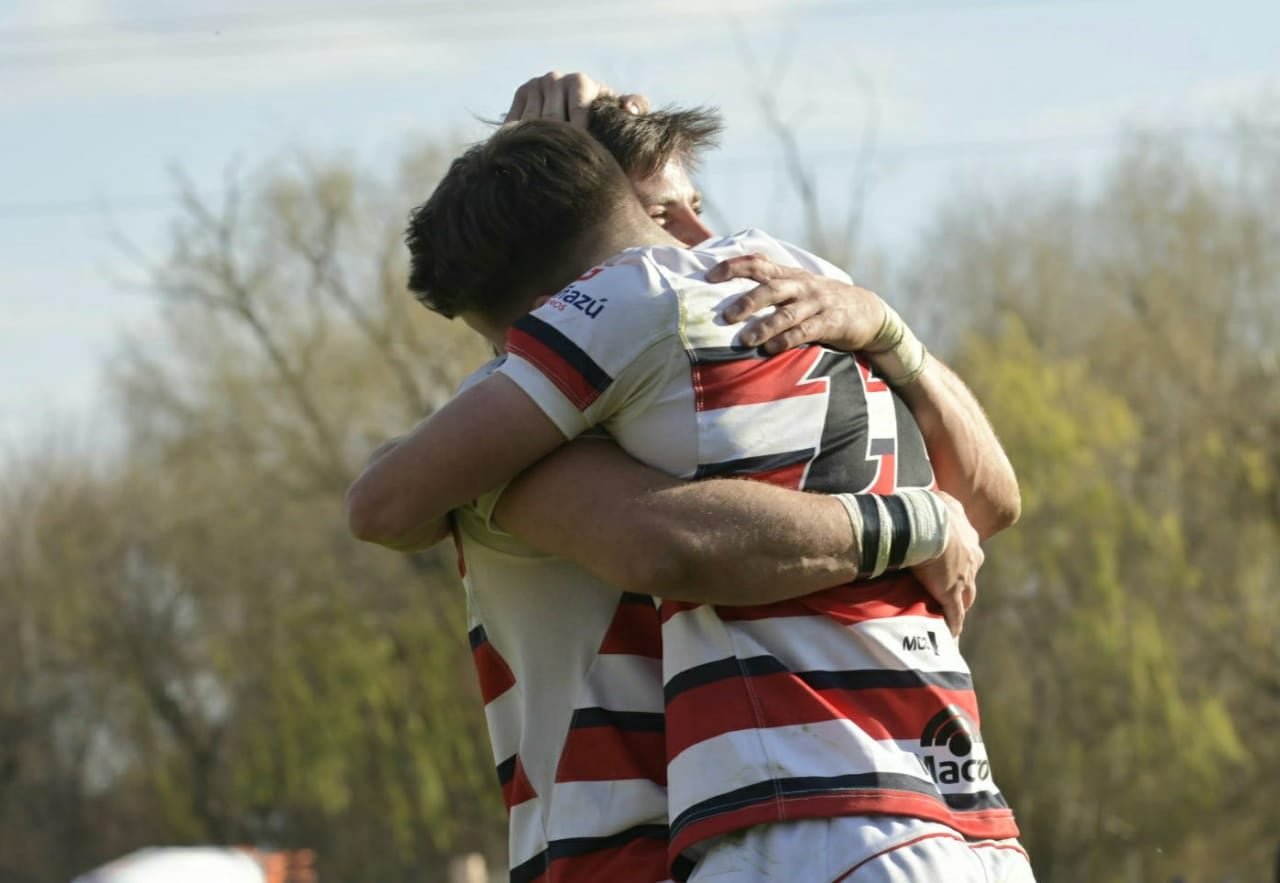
[494,439,982,633]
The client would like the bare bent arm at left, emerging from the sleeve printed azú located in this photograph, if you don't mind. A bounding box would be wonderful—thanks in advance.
[347,374,566,550]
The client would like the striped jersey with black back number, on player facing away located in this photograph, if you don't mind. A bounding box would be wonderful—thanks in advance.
[498,230,1018,879]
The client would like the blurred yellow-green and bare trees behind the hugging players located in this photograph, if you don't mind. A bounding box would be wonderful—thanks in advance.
[0,114,1280,883]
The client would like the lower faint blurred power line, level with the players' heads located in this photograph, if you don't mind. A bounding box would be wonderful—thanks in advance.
[0,125,1235,219]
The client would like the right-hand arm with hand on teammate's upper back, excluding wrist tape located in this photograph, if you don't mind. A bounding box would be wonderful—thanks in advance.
[707,255,1021,539]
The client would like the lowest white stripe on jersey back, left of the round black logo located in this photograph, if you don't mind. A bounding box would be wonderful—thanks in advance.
[667,720,937,819]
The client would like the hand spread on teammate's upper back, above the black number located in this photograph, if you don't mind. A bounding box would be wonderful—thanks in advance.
[707,255,884,353]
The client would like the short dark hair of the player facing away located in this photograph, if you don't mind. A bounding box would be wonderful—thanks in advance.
[404,120,635,320]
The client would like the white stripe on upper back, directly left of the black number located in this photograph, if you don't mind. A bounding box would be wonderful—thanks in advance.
[698,390,829,465]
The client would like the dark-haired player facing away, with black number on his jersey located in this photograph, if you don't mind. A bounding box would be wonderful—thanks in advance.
[352,115,1021,880]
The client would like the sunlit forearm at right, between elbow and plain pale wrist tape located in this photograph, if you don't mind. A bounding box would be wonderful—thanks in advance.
[896,356,1021,539]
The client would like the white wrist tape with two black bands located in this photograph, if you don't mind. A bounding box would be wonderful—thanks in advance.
[832,488,951,578]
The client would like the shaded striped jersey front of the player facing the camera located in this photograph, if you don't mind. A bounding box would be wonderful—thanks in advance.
[453,386,668,883]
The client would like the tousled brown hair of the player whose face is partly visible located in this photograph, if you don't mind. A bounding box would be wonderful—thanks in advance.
[586,96,724,178]
